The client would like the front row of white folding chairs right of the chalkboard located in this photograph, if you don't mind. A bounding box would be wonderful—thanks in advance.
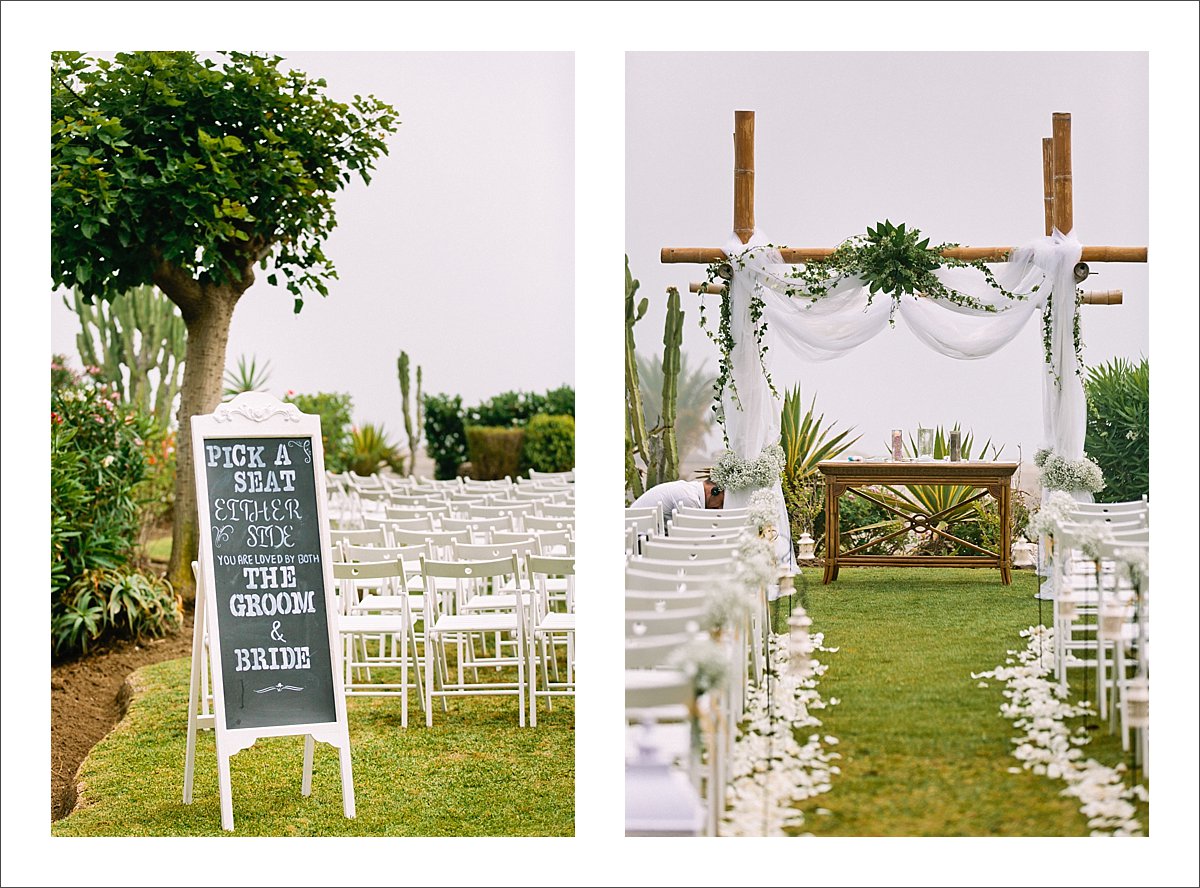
[334,547,575,726]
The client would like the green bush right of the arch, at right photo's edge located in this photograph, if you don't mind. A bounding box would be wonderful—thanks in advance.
[1084,358,1150,503]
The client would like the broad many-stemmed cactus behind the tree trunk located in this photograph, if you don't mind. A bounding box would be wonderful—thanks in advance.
[62,286,187,428]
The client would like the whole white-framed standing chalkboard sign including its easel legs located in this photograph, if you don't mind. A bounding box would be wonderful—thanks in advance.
[184,392,354,829]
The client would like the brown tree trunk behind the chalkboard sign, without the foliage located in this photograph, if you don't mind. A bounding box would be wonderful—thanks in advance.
[157,276,244,600]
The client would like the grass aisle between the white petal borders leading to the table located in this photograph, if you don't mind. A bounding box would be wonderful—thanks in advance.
[797,569,1148,835]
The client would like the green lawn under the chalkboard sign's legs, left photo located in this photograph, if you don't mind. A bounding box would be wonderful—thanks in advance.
[52,659,575,836]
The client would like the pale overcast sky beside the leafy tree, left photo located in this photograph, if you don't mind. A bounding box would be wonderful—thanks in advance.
[52,50,575,440]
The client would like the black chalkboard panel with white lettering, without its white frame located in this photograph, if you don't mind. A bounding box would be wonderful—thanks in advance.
[204,437,336,728]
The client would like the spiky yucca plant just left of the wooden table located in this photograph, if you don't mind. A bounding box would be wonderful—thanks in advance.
[779,383,862,540]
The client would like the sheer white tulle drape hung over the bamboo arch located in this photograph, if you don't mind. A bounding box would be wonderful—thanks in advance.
[705,225,1086,566]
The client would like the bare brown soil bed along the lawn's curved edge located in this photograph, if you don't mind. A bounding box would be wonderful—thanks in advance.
[50,606,193,820]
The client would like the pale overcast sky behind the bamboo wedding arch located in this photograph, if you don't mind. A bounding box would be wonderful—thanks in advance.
[625,53,1153,458]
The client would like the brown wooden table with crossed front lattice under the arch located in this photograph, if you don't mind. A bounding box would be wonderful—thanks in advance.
[817,460,1018,586]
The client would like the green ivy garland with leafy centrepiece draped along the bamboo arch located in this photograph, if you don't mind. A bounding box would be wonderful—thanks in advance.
[700,220,1099,429]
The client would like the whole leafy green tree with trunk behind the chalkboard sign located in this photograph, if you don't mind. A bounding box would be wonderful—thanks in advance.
[50,52,398,589]
